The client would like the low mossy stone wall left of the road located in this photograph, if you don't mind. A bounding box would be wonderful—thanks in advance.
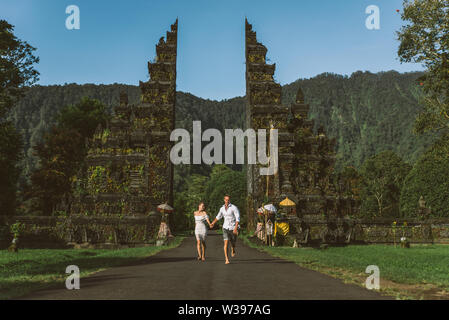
[0,214,161,249]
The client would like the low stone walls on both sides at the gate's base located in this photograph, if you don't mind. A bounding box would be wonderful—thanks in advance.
[5,214,449,249]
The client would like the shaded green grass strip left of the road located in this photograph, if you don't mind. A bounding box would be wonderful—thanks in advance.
[0,237,184,299]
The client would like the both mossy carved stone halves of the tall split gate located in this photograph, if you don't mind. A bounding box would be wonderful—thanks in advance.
[50,20,354,245]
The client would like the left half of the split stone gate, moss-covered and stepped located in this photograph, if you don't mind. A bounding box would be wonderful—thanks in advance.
[70,20,178,216]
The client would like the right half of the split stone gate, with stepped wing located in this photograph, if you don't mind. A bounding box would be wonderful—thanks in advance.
[245,19,340,230]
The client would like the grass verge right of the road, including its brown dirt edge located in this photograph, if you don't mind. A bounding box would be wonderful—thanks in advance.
[242,236,449,299]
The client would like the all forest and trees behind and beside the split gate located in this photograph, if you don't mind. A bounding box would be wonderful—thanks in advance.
[0,1,449,232]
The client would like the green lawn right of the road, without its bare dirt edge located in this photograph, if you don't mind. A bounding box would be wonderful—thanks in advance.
[245,239,449,290]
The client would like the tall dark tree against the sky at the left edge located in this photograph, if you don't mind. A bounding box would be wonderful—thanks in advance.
[0,20,39,215]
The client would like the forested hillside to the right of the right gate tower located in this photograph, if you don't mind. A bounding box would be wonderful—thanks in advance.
[283,71,432,166]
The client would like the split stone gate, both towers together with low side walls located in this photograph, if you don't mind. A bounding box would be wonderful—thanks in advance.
[5,20,442,248]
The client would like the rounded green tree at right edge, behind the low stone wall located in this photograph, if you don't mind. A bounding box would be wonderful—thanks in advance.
[400,137,449,217]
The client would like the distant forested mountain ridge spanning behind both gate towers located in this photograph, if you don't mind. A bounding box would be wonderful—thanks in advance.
[10,71,430,185]
